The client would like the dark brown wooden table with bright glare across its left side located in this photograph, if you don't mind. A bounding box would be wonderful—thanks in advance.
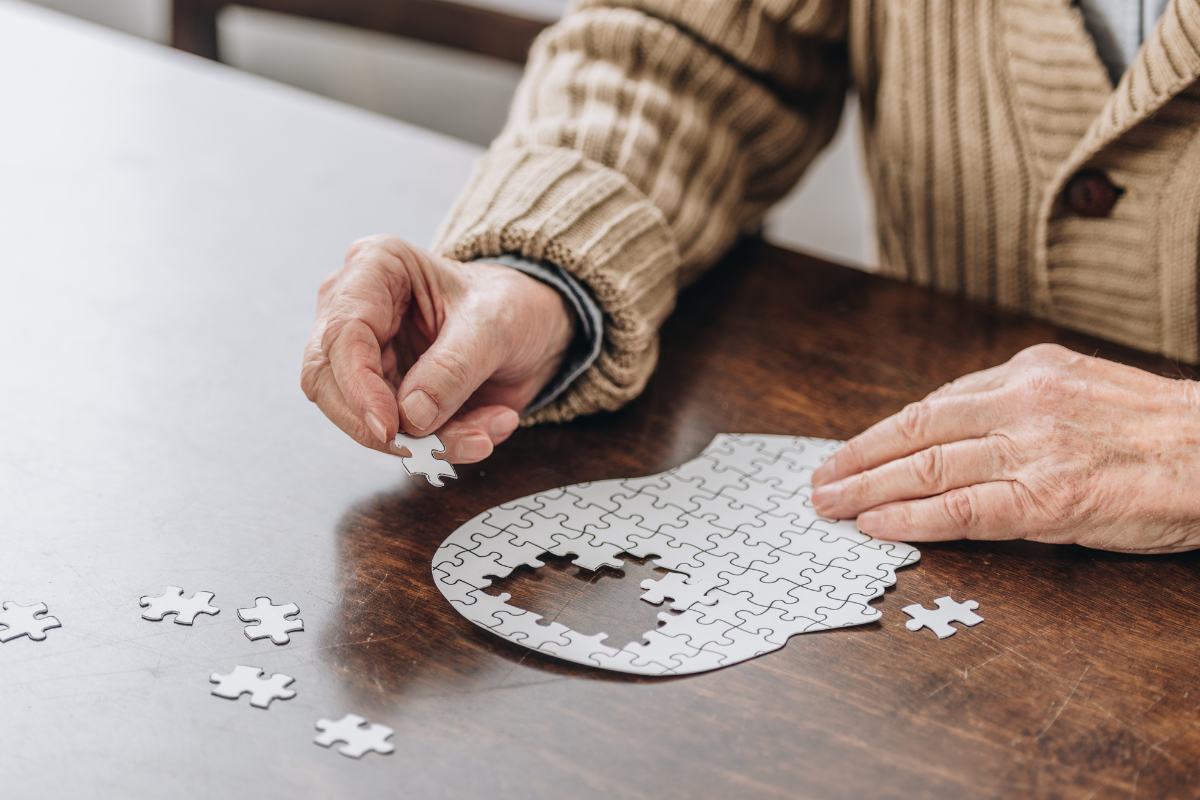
[0,0,1200,800]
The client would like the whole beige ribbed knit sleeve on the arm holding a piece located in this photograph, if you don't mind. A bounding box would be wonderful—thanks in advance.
[433,0,847,421]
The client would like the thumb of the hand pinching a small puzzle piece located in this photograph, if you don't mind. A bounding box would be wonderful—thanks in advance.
[396,321,502,435]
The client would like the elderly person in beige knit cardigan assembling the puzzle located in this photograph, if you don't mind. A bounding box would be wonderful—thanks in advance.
[304,0,1200,552]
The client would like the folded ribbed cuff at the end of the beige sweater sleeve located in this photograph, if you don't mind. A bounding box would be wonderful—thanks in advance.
[432,146,679,422]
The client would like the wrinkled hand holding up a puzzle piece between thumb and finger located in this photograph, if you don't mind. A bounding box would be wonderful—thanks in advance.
[301,236,575,463]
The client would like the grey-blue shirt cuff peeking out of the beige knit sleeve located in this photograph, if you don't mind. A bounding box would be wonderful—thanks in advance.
[476,253,604,414]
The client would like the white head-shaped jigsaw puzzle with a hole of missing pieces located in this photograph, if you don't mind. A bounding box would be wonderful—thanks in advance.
[433,434,920,675]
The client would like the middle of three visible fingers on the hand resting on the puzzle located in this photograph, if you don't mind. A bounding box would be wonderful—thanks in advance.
[812,435,1013,519]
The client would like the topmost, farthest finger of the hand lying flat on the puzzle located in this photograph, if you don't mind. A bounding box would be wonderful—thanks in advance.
[812,392,1007,487]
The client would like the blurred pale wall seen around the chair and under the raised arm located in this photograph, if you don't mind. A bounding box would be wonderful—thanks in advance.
[21,0,875,269]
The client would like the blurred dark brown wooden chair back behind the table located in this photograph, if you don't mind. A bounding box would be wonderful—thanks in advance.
[172,0,548,64]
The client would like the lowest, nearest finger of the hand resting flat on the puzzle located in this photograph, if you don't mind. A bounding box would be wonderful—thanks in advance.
[858,481,1033,542]
